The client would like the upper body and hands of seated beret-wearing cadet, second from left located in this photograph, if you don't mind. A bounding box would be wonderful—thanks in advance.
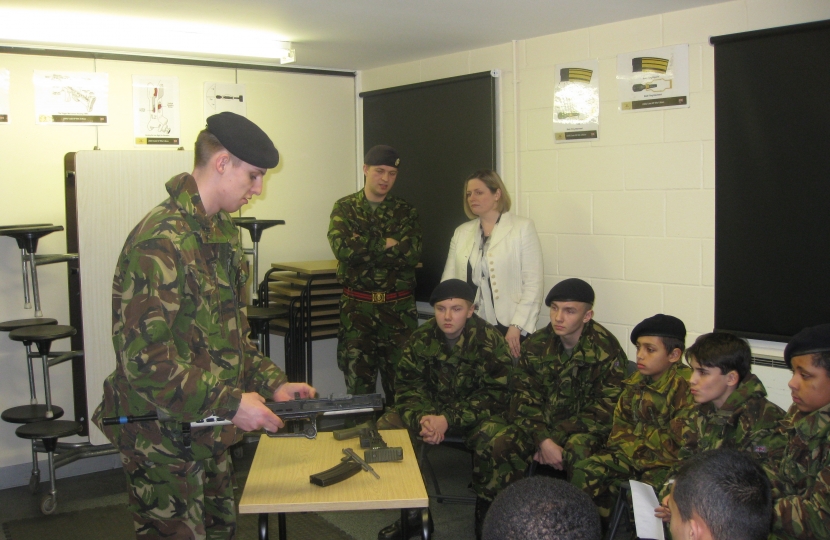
[513,278,628,476]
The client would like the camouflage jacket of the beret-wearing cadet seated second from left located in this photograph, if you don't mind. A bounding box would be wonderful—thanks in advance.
[512,320,628,446]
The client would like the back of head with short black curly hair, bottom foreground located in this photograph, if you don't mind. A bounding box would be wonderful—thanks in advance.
[483,476,602,540]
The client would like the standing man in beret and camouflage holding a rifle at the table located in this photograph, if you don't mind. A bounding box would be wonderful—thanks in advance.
[93,112,315,538]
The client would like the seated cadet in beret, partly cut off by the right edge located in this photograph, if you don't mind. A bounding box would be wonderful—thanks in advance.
[767,324,830,539]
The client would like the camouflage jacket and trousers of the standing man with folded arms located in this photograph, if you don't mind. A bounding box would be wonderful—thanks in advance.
[328,190,421,403]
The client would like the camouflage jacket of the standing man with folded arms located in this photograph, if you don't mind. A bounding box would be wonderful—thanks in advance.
[328,190,421,292]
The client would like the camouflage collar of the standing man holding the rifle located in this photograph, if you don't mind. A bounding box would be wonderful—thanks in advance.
[165,173,237,244]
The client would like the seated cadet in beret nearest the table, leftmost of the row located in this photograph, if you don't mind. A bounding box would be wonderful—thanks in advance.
[378,279,532,540]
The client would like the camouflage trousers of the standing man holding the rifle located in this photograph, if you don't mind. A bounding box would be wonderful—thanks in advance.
[121,452,236,540]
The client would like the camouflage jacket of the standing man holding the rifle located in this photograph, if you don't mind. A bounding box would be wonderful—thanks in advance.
[94,174,286,460]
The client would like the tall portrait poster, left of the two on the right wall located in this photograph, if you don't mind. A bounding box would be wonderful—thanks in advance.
[553,60,599,143]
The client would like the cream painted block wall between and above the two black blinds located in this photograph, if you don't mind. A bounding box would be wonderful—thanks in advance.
[362,0,830,407]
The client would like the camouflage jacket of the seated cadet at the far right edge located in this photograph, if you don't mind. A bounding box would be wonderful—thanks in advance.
[768,405,830,539]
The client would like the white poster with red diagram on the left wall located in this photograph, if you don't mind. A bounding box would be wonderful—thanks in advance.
[133,75,180,146]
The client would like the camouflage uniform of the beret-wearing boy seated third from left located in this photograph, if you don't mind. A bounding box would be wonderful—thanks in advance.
[571,363,697,520]
